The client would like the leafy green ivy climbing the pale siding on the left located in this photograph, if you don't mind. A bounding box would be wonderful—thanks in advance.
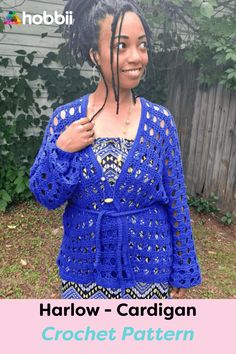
[0,48,89,211]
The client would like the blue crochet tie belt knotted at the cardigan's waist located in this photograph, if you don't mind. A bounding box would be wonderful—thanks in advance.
[69,203,150,296]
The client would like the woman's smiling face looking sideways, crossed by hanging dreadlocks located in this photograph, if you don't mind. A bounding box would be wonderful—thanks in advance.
[93,12,148,89]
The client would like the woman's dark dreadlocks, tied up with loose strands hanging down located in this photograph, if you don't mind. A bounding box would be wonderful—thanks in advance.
[64,0,154,120]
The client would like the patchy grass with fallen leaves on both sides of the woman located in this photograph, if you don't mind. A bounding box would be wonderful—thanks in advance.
[0,201,236,299]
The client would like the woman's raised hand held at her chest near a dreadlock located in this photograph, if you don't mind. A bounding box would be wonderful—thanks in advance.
[56,117,95,152]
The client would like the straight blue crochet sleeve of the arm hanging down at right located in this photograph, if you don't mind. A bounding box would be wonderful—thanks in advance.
[163,114,201,288]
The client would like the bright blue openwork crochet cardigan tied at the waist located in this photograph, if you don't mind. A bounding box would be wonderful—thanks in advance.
[30,95,201,289]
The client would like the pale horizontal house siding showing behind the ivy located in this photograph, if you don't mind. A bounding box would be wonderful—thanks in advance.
[0,0,75,121]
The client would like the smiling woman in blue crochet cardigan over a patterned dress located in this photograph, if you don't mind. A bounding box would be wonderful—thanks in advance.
[30,0,201,299]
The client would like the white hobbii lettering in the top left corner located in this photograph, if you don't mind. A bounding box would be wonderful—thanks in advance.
[22,11,73,25]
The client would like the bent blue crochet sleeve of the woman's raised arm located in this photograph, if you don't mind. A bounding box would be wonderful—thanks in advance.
[29,107,80,209]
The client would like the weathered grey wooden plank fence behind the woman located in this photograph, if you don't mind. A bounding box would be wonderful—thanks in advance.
[165,51,236,214]
